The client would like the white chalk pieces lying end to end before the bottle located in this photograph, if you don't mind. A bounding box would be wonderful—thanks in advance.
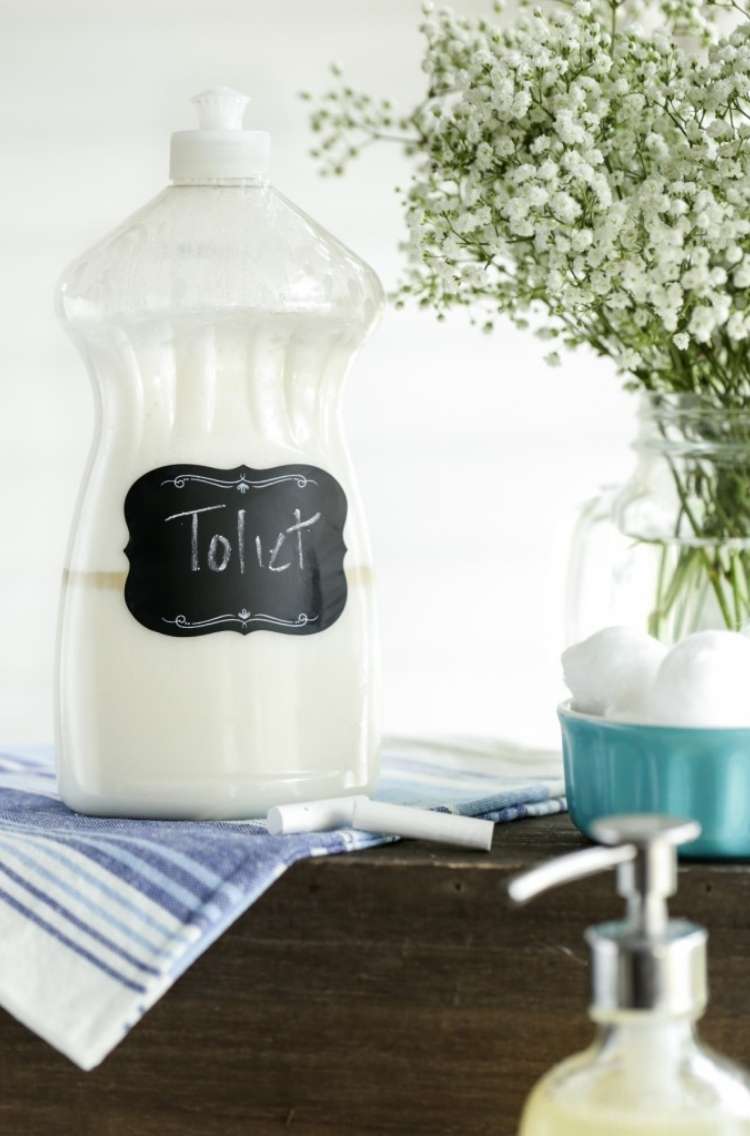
[268,796,494,852]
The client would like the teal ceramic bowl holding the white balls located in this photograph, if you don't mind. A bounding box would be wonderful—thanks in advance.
[558,703,750,859]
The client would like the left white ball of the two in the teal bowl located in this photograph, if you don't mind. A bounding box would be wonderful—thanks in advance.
[563,627,668,718]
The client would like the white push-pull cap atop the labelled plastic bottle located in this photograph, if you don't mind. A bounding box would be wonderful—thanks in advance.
[169,86,270,185]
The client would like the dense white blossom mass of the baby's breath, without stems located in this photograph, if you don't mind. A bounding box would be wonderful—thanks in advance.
[393,0,750,390]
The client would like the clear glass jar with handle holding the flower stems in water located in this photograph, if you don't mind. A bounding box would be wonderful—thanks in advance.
[566,394,750,643]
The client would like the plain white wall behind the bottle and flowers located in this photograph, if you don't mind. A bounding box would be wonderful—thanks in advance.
[0,0,632,744]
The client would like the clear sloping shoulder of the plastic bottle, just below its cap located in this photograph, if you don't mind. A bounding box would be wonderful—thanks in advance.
[57,186,384,325]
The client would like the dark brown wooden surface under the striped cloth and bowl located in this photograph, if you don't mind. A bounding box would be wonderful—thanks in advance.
[0,817,750,1136]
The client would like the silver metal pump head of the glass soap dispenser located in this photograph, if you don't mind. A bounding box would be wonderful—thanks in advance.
[508,815,707,1017]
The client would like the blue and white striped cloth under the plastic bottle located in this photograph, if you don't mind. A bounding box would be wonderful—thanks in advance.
[0,740,565,1069]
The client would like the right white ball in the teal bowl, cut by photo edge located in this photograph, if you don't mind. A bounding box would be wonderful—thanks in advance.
[648,632,750,726]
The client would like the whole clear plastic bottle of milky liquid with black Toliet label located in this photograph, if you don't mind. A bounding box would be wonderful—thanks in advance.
[57,89,382,818]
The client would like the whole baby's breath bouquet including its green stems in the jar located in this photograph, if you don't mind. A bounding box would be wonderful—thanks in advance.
[307,0,750,627]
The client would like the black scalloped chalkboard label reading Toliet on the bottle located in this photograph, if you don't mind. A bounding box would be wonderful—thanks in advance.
[125,465,347,637]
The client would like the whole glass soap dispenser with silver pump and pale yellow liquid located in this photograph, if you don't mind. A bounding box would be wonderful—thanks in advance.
[509,815,750,1136]
